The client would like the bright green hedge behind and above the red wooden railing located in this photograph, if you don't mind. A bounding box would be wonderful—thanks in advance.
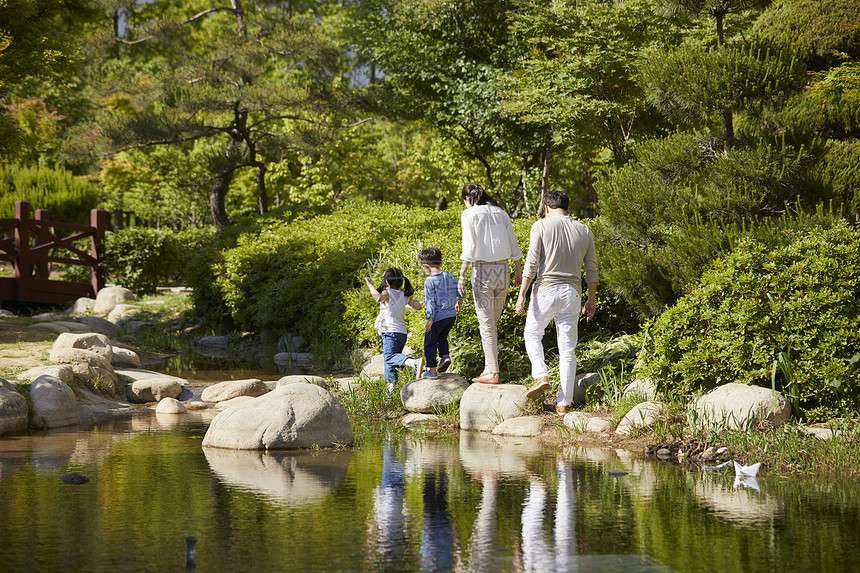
[0,165,100,225]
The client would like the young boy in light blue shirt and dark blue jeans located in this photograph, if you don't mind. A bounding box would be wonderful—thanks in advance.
[418,247,460,378]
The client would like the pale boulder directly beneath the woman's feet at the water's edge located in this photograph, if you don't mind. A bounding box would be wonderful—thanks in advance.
[460,383,528,432]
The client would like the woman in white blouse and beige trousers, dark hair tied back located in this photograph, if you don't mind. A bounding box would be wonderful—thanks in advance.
[458,183,523,384]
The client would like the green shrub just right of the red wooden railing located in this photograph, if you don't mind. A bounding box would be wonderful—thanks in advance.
[102,227,213,294]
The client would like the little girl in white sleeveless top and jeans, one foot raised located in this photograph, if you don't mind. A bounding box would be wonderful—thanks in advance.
[364,268,424,393]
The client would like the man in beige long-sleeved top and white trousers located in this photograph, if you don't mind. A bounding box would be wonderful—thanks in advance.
[517,191,597,414]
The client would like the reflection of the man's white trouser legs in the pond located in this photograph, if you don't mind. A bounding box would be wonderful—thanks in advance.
[522,461,578,573]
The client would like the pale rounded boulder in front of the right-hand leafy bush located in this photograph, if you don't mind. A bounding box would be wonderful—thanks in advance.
[692,382,791,430]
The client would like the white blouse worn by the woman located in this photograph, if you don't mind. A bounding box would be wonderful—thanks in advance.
[460,204,523,263]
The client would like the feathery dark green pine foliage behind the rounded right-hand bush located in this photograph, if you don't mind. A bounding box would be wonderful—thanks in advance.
[592,133,838,317]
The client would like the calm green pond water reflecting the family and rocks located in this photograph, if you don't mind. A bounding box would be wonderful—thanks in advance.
[0,410,860,572]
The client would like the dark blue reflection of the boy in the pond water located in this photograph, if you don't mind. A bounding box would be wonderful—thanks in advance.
[421,469,455,572]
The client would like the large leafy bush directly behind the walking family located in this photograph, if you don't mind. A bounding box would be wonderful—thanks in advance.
[210,203,625,380]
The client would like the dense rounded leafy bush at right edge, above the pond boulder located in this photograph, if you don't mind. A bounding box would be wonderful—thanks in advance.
[639,224,860,421]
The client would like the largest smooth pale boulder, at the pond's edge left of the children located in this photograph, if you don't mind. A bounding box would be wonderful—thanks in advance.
[203,383,353,450]
